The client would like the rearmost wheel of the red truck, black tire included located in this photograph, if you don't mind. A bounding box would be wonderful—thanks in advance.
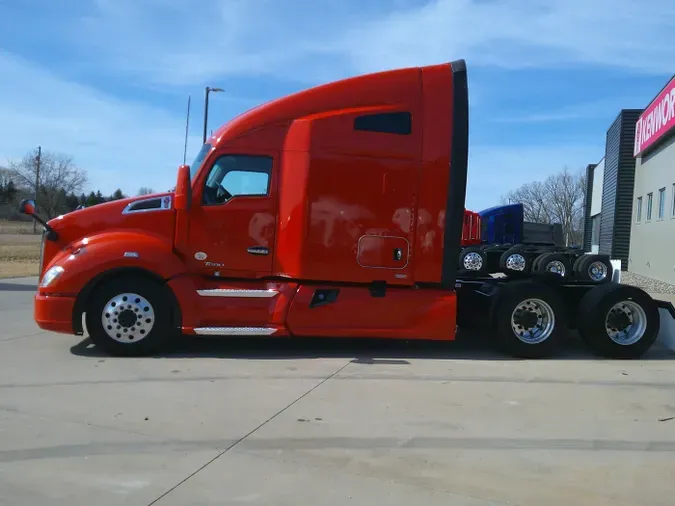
[578,283,661,359]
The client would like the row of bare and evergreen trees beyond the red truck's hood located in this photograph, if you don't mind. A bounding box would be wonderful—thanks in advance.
[0,150,154,219]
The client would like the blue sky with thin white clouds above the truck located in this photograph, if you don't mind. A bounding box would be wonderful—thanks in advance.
[0,0,675,210]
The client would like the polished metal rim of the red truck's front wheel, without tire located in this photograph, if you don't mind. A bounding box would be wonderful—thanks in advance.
[101,293,155,343]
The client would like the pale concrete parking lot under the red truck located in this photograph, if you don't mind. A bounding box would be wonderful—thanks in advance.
[0,279,675,506]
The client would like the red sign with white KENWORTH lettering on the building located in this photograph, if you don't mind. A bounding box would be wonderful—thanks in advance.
[633,77,675,156]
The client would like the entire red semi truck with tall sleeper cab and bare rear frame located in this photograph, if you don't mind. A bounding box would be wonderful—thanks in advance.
[21,60,672,358]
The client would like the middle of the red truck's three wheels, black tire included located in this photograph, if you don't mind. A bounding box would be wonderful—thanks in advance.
[492,280,567,358]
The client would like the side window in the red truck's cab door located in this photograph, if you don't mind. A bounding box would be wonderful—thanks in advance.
[202,155,272,205]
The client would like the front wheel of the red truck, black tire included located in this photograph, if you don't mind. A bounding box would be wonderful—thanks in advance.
[86,276,173,356]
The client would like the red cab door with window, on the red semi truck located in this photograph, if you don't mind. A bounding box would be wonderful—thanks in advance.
[188,151,279,278]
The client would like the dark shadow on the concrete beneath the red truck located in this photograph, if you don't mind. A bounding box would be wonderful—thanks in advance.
[70,332,675,365]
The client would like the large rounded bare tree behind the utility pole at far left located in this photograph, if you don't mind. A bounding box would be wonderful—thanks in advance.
[9,150,87,218]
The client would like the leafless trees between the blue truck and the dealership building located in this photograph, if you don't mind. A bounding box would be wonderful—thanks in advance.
[501,167,586,246]
